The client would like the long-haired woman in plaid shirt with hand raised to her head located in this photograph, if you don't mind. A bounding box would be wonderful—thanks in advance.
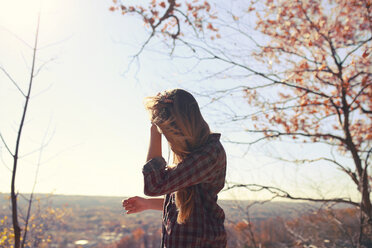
[123,89,226,248]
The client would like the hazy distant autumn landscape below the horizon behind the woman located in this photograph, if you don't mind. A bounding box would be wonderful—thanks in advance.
[0,194,357,248]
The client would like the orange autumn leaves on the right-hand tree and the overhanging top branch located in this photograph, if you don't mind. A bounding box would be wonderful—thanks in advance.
[110,0,372,151]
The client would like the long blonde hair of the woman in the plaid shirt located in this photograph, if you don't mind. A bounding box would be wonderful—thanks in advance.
[145,89,210,224]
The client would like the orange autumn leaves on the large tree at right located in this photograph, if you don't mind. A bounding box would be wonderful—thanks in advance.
[240,0,372,152]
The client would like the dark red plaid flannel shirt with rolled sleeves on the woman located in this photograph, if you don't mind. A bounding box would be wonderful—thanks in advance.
[142,133,226,248]
